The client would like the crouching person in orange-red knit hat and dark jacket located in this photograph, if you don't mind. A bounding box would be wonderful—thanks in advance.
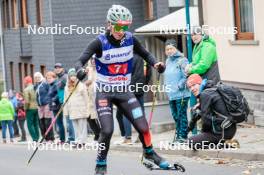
[187,74,236,149]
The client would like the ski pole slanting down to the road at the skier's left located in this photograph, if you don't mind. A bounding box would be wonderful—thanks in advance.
[27,80,80,165]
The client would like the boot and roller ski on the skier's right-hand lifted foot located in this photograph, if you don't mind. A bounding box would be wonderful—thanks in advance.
[141,150,185,172]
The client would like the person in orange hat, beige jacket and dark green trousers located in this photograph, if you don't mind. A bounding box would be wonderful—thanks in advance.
[23,76,39,142]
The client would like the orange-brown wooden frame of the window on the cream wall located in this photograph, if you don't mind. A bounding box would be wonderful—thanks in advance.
[234,0,254,40]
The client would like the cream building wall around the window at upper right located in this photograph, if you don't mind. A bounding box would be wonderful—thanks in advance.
[203,0,264,85]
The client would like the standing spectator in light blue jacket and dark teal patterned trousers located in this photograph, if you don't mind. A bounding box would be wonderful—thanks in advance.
[164,39,190,143]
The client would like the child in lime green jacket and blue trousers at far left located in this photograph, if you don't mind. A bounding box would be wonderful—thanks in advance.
[0,92,15,143]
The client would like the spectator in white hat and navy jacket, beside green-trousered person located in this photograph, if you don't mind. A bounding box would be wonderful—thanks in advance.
[34,72,54,142]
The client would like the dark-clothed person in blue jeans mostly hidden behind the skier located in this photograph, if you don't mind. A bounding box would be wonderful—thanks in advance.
[115,54,151,144]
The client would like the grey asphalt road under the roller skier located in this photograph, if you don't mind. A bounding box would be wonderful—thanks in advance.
[0,144,264,175]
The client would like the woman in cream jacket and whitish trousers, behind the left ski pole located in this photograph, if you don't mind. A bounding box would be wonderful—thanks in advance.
[63,69,89,146]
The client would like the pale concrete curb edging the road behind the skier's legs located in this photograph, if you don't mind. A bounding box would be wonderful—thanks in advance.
[111,145,264,161]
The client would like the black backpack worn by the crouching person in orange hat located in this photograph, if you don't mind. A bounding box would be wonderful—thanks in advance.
[216,82,250,123]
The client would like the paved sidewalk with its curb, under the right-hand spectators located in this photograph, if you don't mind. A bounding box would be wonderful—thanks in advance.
[111,125,264,161]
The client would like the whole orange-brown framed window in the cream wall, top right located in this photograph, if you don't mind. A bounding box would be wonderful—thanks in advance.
[234,0,254,40]
